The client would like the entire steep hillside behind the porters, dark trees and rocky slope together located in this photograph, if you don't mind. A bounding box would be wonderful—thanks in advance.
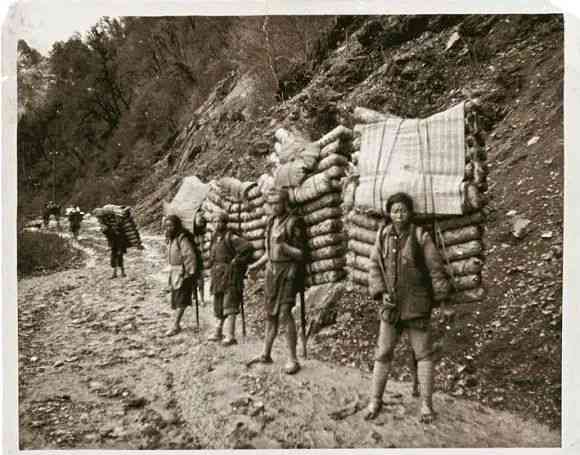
[18,15,564,427]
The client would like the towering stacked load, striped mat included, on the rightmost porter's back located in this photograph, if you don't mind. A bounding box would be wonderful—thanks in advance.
[347,100,488,303]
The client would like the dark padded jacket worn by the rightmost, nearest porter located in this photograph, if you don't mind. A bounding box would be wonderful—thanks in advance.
[369,224,450,321]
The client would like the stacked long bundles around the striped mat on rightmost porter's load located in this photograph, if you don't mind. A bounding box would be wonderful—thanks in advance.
[347,100,488,303]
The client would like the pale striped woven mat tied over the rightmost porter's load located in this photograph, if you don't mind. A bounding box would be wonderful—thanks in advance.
[355,103,465,215]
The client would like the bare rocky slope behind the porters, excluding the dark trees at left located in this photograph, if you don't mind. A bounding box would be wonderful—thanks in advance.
[134,15,563,427]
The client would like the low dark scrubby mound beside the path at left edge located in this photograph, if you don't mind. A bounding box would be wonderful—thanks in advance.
[17,231,81,279]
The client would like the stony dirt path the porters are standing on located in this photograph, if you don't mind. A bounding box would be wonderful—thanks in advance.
[18,219,560,449]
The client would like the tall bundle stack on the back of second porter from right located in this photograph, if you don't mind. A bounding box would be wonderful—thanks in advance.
[273,126,352,286]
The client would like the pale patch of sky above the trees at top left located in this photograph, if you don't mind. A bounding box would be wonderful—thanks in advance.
[16,0,116,56]
